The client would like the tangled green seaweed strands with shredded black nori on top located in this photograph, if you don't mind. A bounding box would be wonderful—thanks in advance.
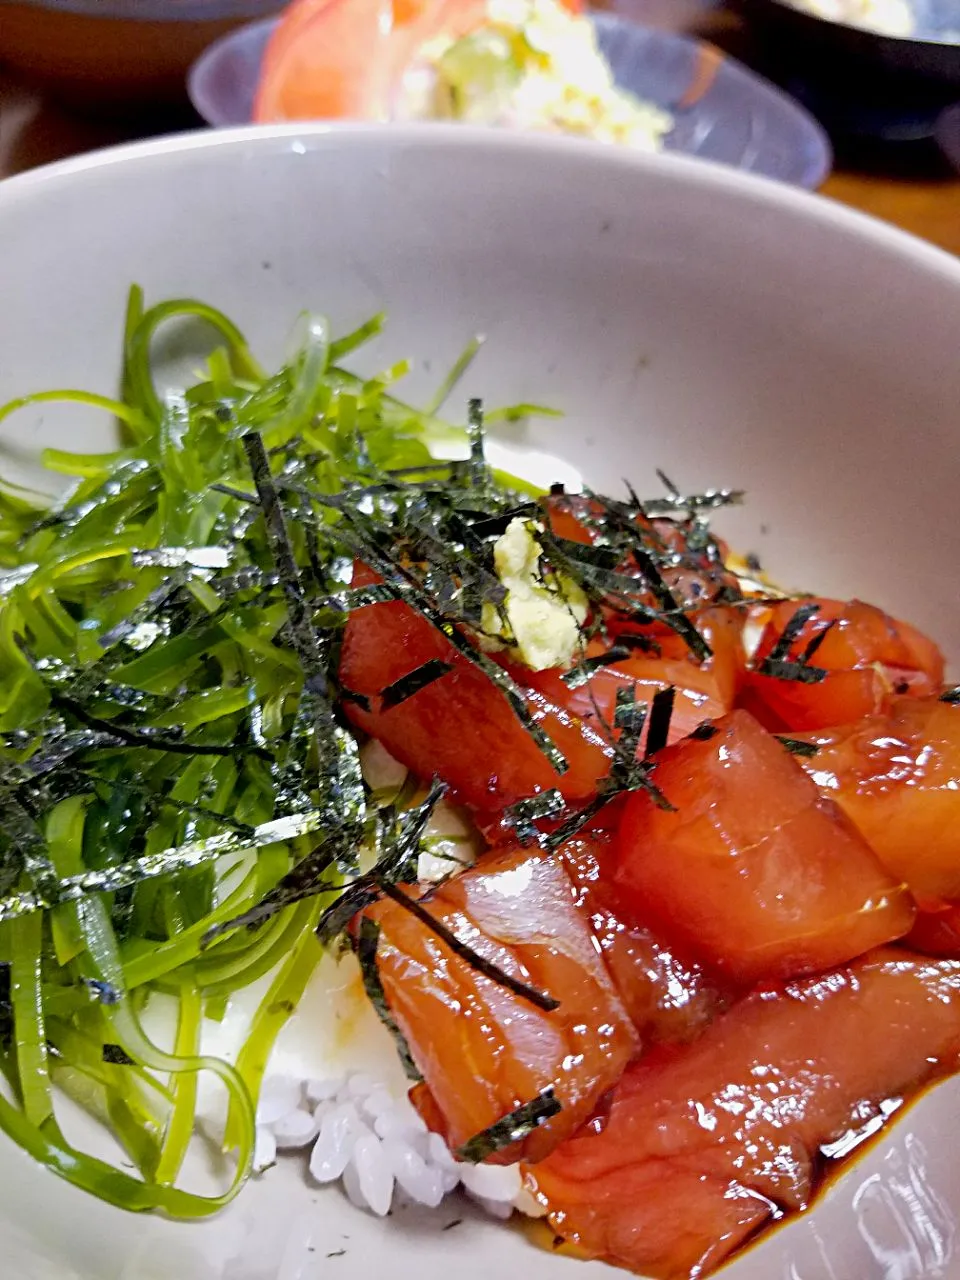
[0,288,737,1219]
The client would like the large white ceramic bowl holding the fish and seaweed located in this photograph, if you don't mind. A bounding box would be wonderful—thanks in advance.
[0,125,960,1280]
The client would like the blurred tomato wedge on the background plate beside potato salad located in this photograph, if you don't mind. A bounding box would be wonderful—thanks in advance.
[253,0,581,123]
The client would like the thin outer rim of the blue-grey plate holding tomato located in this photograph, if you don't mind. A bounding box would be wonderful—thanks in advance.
[187,9,833,191]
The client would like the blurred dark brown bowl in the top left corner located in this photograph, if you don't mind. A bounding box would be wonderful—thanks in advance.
[0,0,282,113]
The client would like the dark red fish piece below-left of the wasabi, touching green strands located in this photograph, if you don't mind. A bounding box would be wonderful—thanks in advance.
[340,566,612,813]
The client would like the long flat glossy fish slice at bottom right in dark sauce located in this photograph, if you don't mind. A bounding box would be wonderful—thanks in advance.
[527,951,960,1280]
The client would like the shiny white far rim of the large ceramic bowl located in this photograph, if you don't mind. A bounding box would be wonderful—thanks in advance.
[0,120,960,280]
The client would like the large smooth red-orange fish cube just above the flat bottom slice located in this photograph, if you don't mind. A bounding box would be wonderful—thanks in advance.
[616,710,915,983]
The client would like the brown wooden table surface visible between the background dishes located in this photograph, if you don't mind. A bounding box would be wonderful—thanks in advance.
[0,0,960,253]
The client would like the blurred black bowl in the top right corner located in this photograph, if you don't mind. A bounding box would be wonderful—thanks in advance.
[737,0,960,141]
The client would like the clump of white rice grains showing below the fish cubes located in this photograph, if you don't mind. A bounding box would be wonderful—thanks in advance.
[253,1071,535,1219]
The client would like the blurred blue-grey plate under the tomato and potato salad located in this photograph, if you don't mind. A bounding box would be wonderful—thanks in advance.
[188,14,832,188]
